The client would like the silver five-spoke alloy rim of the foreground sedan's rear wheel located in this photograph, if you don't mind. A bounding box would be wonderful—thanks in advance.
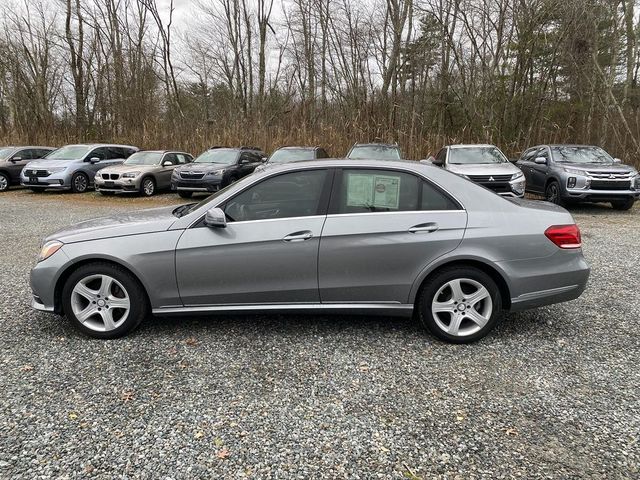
[431,278,493,337]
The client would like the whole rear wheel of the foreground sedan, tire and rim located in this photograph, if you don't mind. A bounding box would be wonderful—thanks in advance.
[417,266,502,343]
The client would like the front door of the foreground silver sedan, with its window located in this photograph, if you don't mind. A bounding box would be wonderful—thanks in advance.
[176,169,332,306]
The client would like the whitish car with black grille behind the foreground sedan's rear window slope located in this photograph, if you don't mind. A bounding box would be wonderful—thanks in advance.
[431,145,525,197]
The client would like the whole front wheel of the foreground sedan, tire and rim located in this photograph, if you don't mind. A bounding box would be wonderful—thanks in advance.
[62,262,149,339]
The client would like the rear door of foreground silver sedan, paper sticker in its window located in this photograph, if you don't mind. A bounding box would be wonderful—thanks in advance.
[318,168,467,303]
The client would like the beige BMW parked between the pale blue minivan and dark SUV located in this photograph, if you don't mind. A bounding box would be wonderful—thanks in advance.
[95,150,193,197]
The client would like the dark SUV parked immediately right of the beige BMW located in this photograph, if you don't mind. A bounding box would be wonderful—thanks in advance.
[171,147,267,198]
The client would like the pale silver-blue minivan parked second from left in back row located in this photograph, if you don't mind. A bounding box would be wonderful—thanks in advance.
[20,143,138,193]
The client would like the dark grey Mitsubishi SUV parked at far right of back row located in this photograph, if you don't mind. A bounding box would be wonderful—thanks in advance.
[517,145,640,210]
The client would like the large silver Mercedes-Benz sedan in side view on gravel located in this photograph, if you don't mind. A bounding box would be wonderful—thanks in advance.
[31,160,589,343]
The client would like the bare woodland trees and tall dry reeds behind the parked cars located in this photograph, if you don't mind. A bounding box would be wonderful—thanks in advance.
[0,0,640,165]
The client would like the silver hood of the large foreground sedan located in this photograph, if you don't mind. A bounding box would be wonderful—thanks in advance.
[45,205,176,243]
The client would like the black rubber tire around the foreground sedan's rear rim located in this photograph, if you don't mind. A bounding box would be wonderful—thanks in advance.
[418,266,502,343]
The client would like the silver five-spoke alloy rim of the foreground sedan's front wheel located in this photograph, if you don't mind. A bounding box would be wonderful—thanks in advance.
[71,274,131,332]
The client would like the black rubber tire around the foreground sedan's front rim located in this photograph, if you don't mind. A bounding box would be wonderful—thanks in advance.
[62,262,149,339]
